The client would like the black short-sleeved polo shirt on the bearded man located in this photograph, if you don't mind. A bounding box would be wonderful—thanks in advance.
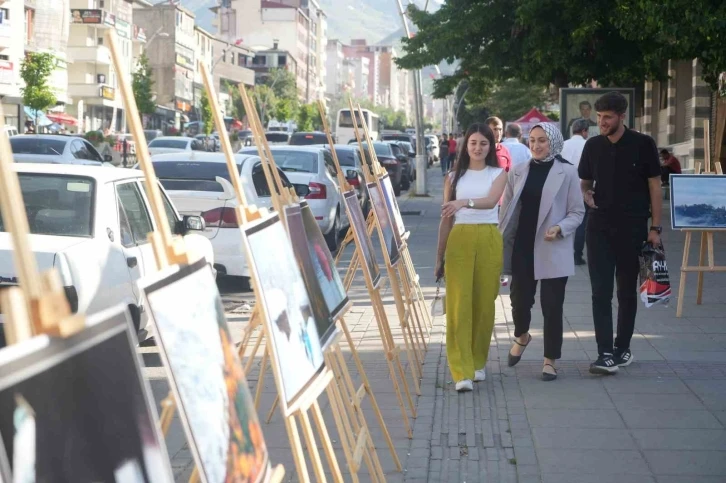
[578,128,660,218]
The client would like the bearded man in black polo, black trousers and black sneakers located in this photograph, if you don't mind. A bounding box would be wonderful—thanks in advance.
[578,92,662,374]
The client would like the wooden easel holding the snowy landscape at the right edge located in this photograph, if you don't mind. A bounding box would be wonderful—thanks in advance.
[671,119,726,317]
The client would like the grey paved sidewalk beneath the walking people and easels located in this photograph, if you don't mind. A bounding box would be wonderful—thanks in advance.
[141,167,726,483]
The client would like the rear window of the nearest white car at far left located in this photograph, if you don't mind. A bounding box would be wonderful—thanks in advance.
[0,173,95,237]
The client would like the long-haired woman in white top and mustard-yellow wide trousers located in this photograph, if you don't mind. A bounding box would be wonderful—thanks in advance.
[434,123,507,391]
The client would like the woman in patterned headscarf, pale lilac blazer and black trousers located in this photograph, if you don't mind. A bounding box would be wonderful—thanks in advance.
[499,123,585,381]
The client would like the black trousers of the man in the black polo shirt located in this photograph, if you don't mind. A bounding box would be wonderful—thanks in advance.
[586,214,648,355]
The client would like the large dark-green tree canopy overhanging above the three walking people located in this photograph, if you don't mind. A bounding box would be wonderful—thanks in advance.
[397,0,663,98]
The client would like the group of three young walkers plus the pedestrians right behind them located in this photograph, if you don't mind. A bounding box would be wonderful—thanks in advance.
[435,92,668,391]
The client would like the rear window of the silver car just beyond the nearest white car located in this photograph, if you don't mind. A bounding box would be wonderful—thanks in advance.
[152,161,242,193]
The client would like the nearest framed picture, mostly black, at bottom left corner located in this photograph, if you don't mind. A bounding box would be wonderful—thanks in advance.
[0,307,174,483]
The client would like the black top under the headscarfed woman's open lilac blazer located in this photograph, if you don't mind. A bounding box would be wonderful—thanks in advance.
[512,161,559,264]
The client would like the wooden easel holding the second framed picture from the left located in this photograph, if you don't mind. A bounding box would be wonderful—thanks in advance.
[106,31,285,483]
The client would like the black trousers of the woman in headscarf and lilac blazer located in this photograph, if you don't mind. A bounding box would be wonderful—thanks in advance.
[509,258,567,359]
